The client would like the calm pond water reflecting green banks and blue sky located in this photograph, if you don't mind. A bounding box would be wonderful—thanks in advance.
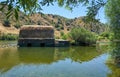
[0,41,120,77]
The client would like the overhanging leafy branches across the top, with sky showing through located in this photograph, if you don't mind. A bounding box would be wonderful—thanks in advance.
[0,0,106,19]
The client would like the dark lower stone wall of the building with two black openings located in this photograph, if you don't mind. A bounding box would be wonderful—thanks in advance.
[18,39,55,47]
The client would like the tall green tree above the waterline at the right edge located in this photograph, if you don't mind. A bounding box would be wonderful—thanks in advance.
[105,0,120,40]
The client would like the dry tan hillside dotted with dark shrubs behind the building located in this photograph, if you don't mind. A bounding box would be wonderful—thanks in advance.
[0,12,104,36]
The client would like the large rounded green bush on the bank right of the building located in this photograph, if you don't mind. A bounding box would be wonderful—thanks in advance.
[69,27,96,45]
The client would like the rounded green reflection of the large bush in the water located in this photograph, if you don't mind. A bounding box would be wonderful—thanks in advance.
[70,47,100,62]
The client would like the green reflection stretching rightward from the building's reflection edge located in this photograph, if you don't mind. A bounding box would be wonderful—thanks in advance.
[55,47,108,62]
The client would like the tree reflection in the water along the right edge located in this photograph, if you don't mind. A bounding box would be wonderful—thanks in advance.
[107,42,120,77]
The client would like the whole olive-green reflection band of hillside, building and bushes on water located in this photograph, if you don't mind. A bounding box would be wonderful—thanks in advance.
[0,47,109,71]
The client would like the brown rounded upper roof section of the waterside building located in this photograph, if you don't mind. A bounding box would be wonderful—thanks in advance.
[19,25,54,38]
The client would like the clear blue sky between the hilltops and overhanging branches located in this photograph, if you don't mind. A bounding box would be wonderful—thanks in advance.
[41,3,107,23]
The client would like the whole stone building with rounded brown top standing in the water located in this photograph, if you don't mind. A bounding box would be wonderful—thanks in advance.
[18,25,55,47]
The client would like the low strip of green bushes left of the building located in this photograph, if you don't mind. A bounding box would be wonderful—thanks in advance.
[0,34,18,40]
